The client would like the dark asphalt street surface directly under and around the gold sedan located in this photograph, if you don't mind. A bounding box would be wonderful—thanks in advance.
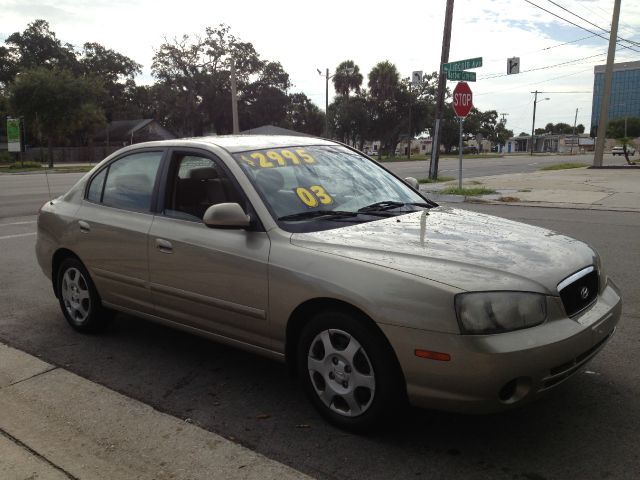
[0,204,640,480]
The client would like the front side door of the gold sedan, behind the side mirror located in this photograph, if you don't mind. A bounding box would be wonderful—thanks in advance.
[149,150,270,347]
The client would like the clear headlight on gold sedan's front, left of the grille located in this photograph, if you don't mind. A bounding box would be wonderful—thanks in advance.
[455,292,547,335]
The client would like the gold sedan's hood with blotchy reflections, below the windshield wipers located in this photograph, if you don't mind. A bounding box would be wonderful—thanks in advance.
[291,207,596,295]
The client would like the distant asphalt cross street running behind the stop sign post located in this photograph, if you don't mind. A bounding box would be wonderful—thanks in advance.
[384,154,626,179]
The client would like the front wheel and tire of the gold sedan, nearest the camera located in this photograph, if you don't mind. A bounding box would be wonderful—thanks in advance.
[296,310,404,432]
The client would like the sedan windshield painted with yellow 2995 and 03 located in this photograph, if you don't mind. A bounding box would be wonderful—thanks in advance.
[233,145,435,231]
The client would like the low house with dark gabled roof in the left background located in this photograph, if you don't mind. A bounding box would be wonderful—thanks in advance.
[93,118,176,146]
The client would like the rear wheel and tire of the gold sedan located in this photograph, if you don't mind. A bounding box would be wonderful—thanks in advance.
[56,257,111,333]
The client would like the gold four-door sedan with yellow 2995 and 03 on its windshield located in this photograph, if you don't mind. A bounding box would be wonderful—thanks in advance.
[36,136,621,431]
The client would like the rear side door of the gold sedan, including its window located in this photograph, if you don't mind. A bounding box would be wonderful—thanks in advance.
[74,150,164,313]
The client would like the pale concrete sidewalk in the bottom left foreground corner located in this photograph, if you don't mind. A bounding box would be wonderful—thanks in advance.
[0,344,309,480]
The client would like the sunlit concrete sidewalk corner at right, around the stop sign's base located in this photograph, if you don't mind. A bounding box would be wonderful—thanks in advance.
[420,167,640,212]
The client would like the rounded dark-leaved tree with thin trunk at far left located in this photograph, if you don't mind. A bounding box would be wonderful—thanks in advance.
[9,67,104,167]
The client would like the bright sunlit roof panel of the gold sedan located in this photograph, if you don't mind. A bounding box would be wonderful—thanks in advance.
[137,135,339,153]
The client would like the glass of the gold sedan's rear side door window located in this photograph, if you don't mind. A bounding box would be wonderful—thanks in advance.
[100,152,162,211]
